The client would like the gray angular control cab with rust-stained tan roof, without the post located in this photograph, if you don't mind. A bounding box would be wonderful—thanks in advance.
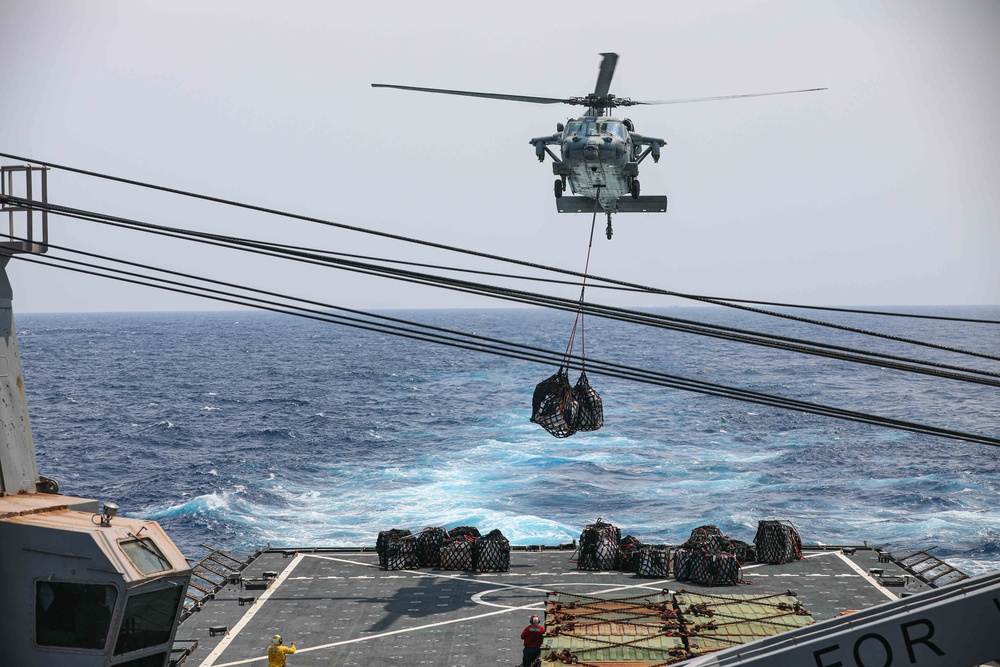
[0,493,191,667]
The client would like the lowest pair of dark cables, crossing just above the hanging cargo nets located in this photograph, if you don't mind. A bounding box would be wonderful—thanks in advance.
[13,254,1000,446]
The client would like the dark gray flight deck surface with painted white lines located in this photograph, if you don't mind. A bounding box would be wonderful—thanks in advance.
[177,549,922,667]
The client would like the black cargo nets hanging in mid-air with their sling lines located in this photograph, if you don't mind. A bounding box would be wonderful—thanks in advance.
[531,213,604,438]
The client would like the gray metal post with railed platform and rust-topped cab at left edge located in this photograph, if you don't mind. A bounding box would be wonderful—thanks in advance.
[0,217,191,667]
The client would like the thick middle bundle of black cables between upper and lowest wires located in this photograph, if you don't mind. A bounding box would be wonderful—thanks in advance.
[12,198,1000,386]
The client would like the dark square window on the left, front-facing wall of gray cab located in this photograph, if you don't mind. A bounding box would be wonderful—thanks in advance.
[35,581,118,649]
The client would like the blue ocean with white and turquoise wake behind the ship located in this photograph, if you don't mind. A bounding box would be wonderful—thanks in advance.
[17,307,1000,574]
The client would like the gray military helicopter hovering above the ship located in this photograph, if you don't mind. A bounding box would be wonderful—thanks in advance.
[372,53,826,239]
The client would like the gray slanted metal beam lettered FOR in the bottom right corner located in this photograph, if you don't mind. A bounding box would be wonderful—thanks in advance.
[681,572,1000,667]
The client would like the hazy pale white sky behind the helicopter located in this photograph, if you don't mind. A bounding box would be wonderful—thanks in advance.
[0,0,1000,312]
